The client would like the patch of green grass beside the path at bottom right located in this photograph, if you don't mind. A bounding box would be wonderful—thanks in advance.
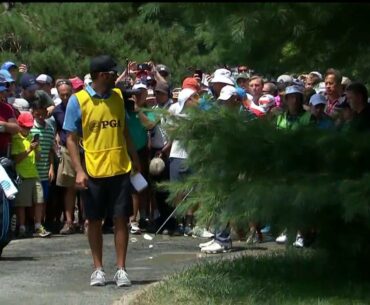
[133,251,370,305]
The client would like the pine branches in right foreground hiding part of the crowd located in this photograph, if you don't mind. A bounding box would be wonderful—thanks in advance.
[163,107,370,268]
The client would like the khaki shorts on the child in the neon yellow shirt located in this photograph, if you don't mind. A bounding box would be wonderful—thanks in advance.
[14,178,44,208]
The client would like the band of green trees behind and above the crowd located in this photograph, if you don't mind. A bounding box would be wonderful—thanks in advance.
[0,3,370,83]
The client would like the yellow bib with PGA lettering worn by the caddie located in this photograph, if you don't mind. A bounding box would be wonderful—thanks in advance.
[76,89,131,178]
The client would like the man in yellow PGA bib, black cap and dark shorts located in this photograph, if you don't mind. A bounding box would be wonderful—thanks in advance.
[63,55,141,287]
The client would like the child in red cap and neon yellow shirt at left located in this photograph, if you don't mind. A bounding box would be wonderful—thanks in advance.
[11,112,50,237]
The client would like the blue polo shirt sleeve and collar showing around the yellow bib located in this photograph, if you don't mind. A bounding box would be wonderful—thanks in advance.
[63,86,111,136]
